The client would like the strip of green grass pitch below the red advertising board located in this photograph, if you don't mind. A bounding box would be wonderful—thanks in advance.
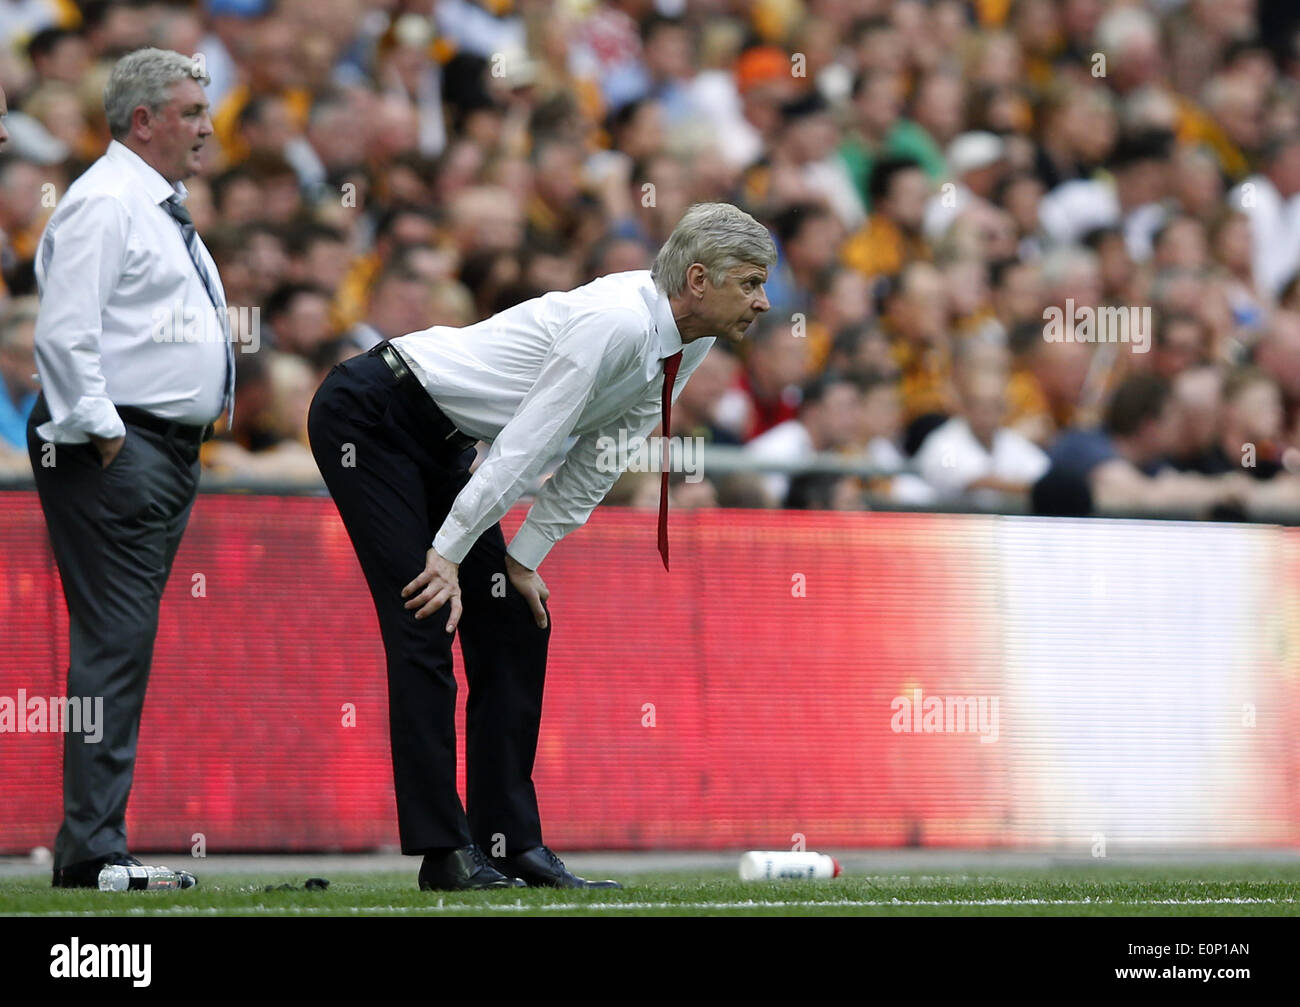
[0,863,1300,917]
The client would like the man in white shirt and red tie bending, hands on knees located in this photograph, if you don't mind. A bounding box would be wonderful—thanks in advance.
[308,203,776,890]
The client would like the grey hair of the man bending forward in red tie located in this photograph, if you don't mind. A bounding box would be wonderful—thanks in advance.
[650,203,776,298]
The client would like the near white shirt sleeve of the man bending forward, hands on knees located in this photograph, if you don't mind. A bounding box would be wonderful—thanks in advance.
[433,309,640,563]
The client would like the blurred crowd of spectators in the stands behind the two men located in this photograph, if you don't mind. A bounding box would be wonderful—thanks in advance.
[0,0,1300,516]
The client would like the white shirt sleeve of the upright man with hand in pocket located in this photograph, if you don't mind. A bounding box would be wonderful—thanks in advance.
[35,195,130,442]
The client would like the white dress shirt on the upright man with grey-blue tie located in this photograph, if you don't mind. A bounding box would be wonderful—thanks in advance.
[35,140,226,444]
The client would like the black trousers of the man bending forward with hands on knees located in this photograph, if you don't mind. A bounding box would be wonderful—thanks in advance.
[307,353,550,855]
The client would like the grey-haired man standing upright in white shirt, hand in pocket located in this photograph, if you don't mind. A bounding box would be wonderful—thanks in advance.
[27,49,234,887]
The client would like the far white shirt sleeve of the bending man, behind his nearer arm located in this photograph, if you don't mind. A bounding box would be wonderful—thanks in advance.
[507,339,714,570]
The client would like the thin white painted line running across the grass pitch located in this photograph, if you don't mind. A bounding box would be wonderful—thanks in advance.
[0,898,1295,916]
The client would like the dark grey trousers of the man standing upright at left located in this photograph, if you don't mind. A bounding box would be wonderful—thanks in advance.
[27,398,199,869]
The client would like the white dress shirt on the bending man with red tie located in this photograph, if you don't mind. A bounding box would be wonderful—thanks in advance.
[393,269,714,569]
